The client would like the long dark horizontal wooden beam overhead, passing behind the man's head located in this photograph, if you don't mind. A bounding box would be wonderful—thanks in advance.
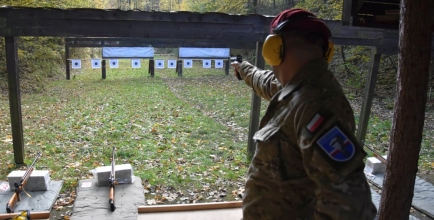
[0,8,404,43]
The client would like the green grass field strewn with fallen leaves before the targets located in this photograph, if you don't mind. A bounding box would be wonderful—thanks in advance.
[0,57,434,209]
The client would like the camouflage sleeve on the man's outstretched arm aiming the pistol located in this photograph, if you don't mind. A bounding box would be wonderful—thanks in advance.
[240,61,282,101]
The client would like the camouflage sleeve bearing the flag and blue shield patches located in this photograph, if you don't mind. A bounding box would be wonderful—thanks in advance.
[294,102,376,220]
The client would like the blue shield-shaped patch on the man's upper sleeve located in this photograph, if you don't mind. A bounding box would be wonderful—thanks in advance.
[316,126,355,162]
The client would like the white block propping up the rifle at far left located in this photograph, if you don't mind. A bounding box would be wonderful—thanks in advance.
[8,170,50,192]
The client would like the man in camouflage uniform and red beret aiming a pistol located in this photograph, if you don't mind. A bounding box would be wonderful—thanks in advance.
[232,9,377,220]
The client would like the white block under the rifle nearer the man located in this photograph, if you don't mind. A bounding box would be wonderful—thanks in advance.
[93,164,133,186]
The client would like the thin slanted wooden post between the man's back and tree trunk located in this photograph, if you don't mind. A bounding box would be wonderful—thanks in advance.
[356,47,381,143]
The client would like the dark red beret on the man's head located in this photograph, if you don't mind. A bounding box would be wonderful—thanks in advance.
[270,9,331,40]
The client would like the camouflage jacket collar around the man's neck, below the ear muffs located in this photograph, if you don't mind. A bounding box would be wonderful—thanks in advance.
[278,59,328,101]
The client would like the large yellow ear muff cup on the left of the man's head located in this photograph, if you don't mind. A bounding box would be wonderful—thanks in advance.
[262,34,284,66]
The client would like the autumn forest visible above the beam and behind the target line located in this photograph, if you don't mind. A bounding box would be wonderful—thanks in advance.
[0,0,400,95]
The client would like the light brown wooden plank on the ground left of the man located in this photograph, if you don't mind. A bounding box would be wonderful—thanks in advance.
[137,201,242,213]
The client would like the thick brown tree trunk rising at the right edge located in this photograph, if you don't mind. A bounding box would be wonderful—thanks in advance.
[379,0,434,220]
